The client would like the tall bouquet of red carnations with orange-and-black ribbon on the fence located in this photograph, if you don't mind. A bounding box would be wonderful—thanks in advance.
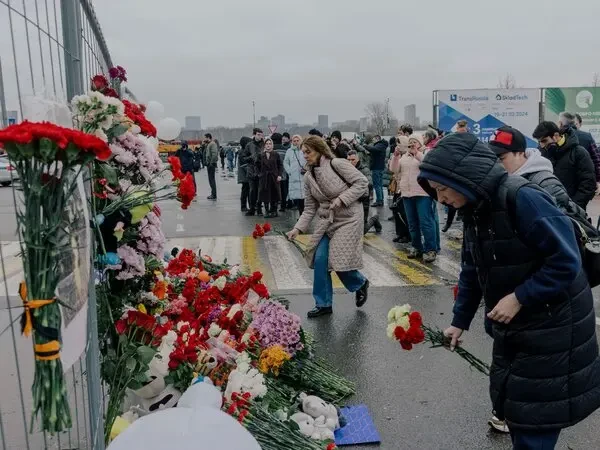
[0,121,111,433]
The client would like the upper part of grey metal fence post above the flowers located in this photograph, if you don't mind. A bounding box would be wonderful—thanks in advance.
[60,0,84,102]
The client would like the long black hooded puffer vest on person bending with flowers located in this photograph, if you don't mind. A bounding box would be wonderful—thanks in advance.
[419,133,600,430]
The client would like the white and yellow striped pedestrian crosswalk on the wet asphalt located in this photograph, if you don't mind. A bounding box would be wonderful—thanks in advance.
[168,235,460,292]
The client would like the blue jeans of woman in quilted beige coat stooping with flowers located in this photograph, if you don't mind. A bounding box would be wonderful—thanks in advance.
[313,236,367,308]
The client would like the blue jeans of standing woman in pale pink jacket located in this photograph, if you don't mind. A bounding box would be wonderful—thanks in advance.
[402,197,439,253]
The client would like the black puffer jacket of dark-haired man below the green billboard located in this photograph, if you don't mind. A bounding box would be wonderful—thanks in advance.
[542,128,596,209]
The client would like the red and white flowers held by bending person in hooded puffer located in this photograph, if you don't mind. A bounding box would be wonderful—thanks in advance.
[387,304,490,375]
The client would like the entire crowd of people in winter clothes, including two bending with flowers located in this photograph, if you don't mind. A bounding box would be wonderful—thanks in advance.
[173,112,600,450]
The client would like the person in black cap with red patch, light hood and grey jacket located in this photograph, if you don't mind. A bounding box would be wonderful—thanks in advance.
[489,126,596,235]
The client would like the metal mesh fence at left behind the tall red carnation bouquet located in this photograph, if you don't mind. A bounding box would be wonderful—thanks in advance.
[0,0,112,450]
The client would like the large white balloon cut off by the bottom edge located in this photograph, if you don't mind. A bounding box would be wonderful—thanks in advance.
[108,407,260,450]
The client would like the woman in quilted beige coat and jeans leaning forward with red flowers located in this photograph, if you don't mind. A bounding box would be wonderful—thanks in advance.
[287,136,369,318]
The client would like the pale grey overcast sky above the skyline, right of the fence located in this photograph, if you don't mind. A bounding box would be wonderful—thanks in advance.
[94,0,600,126]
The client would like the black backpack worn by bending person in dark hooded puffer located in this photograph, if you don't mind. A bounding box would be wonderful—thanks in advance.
[506,178,600,288]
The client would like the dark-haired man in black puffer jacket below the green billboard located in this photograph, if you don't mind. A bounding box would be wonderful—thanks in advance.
[533,122,596,209]
